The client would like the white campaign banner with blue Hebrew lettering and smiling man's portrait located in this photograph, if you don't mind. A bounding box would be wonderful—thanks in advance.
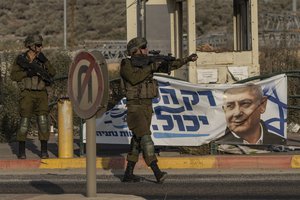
[83,74,287,146]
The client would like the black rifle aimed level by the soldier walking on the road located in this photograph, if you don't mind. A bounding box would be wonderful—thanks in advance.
[131,50,176,73]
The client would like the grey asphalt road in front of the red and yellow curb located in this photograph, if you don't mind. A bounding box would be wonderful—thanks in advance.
[0,169,299,200]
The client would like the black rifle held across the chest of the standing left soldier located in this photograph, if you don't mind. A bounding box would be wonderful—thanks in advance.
[17,54,53,85]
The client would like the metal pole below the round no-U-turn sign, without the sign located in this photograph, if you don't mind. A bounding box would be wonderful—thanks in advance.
[86,116,97,197]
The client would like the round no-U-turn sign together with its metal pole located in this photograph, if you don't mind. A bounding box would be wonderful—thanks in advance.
[68,51,109,197]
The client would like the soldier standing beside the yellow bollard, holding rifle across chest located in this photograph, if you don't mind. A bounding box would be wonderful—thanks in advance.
[11,34,56,159]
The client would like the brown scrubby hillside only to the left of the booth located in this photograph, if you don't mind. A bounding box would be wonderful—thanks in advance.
[0,0,126,46]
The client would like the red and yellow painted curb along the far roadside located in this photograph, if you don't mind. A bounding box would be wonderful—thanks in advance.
[0,155,300,170]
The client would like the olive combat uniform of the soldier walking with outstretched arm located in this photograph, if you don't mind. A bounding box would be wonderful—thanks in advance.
[121,58,188,165]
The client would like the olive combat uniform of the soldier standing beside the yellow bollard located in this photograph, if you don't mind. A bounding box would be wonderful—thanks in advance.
[11,36,56,159]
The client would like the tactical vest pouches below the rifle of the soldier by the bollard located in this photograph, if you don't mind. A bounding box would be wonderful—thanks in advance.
[19,76,46,90]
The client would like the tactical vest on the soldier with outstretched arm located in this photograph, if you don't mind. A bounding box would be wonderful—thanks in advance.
[123,76,158,100]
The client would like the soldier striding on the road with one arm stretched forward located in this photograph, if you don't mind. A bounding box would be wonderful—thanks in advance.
[120,37,198,183]
